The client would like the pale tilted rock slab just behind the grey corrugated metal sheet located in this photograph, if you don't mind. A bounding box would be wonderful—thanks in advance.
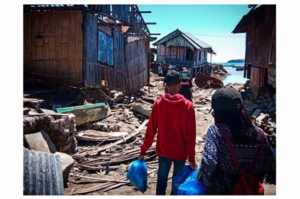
[25,131,56,153]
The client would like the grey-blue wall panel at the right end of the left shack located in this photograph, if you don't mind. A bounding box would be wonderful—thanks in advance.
[126,40,149,93]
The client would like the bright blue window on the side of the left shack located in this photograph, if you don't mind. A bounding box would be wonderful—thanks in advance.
[98,31,114,65]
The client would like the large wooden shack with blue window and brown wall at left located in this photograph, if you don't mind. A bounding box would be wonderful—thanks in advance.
[24,4,156,93]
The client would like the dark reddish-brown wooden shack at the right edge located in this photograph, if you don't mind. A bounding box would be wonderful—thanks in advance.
[233,5,276,91]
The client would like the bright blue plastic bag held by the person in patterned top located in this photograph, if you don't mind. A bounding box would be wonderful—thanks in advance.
[177,169,206,195]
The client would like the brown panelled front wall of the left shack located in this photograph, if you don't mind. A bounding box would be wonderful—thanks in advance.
[24,11,83,83]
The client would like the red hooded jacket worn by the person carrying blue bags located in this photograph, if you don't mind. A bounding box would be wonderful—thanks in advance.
[141,94,196,162]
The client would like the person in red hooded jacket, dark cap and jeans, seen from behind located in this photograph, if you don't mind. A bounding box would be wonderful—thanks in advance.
[139,71,196,195]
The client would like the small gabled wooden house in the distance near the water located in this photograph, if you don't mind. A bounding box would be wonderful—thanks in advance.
[153,29,215,76]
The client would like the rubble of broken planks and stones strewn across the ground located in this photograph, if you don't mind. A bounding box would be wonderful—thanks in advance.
[23,69,276,195]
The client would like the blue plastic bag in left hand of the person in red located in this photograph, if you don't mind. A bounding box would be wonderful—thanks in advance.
[126,159,148,193]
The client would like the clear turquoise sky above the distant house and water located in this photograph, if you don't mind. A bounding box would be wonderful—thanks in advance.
[138,4,250,63]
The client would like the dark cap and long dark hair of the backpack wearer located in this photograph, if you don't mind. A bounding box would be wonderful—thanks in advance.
[212,88,257,142]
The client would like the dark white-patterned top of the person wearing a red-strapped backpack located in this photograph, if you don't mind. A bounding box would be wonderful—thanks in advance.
[200,124,275,195]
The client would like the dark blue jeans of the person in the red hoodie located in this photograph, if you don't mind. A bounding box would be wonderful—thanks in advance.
[156,157,185,195]
